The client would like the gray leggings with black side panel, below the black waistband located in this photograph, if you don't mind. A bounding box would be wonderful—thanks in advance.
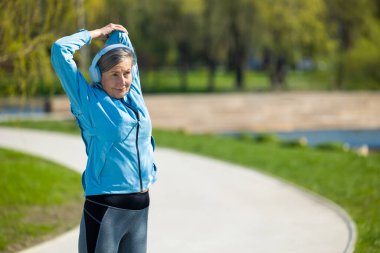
[79,200,149,253]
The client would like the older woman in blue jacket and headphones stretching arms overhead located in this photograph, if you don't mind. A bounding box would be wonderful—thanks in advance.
[52,24,156,253]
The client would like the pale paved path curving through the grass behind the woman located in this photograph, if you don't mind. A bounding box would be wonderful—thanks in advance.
[0,128,356,253]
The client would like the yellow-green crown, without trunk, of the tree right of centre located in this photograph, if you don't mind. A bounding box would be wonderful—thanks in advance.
[256,0,330,56]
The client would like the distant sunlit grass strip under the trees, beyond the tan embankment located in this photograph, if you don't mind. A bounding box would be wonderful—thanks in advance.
[0,67,380,97]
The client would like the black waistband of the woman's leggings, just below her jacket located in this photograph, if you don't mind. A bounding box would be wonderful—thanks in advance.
[86,191,150,210]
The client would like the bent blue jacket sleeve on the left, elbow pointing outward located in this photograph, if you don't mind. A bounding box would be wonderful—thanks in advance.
[51,30,91,111]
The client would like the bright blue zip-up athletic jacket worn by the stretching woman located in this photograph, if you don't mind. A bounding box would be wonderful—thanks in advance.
[51,30,156,196]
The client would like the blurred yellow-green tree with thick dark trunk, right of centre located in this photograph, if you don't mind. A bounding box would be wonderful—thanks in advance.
[254,0,332,89]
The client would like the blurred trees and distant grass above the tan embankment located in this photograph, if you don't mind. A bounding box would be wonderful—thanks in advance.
[0,0,380,97]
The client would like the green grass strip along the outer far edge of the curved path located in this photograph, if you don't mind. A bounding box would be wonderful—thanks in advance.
[0,121,380,253]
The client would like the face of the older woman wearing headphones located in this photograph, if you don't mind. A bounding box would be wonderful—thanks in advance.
[102,58,132,99]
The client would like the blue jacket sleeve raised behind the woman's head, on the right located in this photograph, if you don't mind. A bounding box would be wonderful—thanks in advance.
[106,31,142,95]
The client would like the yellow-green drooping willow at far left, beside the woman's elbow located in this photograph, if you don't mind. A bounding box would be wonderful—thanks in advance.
[0,0,75,95]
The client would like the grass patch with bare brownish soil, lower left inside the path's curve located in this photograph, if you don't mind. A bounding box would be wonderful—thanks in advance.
[0,149,83,253]
